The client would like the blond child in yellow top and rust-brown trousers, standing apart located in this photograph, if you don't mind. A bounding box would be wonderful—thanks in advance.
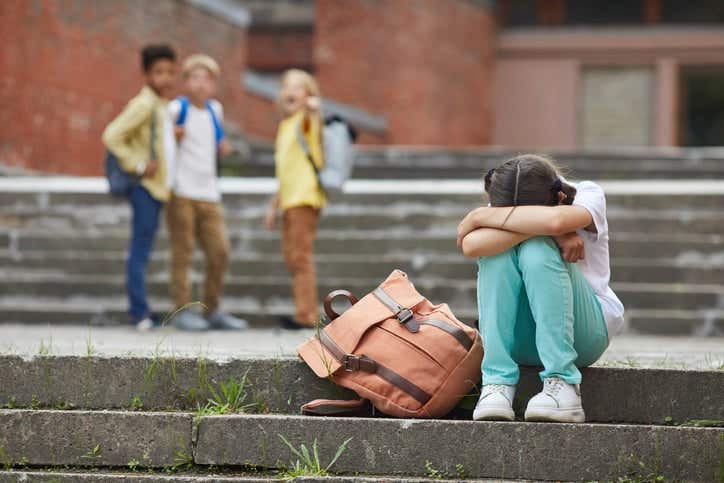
[265,69,327,329]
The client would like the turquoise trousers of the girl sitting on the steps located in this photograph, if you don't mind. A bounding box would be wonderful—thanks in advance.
[478,236,608,385]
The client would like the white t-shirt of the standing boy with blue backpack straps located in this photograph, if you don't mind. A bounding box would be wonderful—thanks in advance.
[168,99,224,202]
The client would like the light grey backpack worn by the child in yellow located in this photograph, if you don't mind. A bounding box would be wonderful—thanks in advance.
[297,115,357,196]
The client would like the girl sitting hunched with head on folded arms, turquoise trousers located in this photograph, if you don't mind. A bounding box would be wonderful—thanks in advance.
[457,154,623,422]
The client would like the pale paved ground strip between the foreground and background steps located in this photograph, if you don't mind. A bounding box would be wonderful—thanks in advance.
[0,324,724,370]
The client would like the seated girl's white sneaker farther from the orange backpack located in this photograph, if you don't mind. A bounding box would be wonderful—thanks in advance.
[525,377,586,423]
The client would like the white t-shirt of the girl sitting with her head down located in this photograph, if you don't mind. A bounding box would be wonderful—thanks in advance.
[573,181,624,338]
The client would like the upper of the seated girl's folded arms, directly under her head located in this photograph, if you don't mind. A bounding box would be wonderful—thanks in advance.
[468,205,595,236]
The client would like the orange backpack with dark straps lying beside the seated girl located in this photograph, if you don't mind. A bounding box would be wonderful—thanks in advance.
[298,270,483,418]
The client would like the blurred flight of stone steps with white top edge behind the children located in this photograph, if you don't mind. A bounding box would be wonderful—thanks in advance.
[0,178,724,335]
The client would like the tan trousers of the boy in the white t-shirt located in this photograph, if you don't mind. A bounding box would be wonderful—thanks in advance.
[166,195,229,314]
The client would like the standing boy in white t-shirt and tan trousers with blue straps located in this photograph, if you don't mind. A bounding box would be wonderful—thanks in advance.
[167,54,248,330]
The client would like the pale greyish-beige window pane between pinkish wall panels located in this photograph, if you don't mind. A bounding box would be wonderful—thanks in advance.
[578,67,654,148]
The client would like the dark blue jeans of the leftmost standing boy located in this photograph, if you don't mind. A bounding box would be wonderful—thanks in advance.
[126,185,163,323]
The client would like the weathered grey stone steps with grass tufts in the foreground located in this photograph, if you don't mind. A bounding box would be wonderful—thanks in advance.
[0,352,724,483]
